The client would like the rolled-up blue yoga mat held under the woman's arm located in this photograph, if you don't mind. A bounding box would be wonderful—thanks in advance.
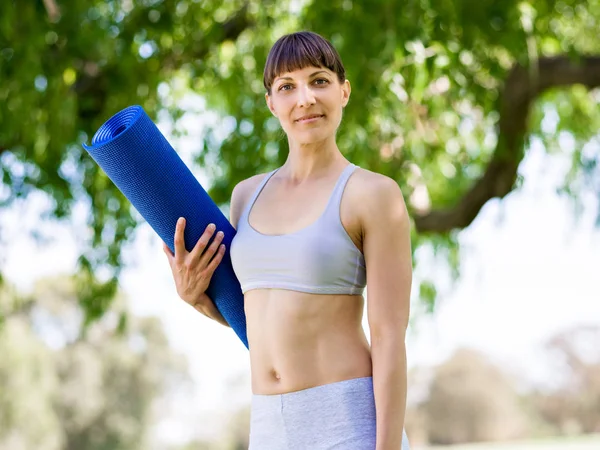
[83,106,248,348]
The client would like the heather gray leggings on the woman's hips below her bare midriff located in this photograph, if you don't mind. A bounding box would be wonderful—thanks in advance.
[249,377,409,450]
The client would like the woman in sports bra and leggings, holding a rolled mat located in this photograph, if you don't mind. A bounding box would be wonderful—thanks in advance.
[164,32,412,450]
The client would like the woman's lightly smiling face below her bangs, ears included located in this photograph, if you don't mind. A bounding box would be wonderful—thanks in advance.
[266,67,350,144]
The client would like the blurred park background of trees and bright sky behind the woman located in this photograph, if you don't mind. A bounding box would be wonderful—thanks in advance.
[0,0,600,450]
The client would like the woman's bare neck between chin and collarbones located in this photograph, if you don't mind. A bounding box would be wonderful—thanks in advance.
[280,138,348,183]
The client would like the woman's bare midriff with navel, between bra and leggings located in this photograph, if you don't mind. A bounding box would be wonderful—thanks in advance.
[245,289,371,395]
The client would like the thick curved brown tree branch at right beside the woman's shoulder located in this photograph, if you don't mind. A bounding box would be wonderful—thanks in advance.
[413,56,600,233]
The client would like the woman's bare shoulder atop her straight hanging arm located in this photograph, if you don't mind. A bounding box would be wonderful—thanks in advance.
[348,167,408,231]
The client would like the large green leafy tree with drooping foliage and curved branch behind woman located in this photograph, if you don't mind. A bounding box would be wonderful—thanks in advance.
[0,0,600,319]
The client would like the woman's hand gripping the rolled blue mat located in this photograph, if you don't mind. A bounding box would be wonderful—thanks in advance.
[163,217,225,314]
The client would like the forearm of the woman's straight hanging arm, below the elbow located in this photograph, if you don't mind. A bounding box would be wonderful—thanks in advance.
[371,336,407,450]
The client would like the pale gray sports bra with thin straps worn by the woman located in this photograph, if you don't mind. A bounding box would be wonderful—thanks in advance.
[230,164,366,295]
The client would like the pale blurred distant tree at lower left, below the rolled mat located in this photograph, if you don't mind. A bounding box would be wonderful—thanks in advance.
[0,278,190,450]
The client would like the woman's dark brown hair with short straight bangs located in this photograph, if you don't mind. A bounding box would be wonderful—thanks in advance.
[263,31,346,94]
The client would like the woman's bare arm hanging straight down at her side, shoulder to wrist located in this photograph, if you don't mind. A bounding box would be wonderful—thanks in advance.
[361,174,412,450]
